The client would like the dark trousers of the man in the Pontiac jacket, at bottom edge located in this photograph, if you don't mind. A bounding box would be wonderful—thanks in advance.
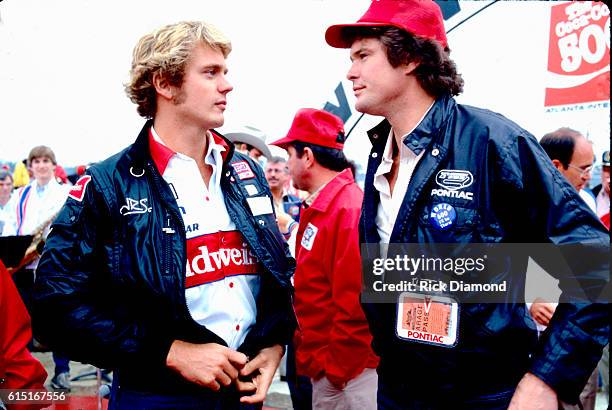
[377,379,514,410]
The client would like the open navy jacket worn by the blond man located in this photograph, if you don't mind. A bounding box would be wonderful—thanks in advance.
[32,122,296,393]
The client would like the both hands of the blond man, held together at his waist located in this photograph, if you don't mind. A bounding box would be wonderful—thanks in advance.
[166,340,283,404]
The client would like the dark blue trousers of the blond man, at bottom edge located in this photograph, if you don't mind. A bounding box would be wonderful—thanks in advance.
[108,375,261,410]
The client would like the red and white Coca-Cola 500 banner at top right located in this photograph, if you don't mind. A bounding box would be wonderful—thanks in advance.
[544,1,610,107]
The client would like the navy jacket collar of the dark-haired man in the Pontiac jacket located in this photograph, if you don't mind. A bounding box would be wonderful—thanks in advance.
[368,95,456,155]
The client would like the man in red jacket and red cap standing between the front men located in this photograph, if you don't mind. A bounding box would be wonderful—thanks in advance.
[273,108,378,409]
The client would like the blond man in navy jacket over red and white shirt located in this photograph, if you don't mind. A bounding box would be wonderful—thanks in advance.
[33,22,295,409]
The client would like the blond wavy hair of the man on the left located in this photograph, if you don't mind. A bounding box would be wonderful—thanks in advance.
[125,21,232,118]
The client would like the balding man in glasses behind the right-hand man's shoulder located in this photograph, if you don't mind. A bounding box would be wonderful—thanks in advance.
[540,127,596,212]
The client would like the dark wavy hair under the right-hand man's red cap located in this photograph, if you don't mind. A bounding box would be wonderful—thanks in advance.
[342,26,463,98]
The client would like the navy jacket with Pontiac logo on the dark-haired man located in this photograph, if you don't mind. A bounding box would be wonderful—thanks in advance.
[360,96,610,403]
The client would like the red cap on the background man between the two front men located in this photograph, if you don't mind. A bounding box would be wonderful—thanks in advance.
[271,108,345,150]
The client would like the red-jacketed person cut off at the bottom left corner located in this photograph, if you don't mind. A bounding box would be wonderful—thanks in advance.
[0,261,47,409]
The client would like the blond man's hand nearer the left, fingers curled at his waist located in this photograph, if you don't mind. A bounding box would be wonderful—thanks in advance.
[166,340,247,391]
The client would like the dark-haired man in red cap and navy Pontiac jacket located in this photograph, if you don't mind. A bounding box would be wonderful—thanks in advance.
[325,0,609,409]
